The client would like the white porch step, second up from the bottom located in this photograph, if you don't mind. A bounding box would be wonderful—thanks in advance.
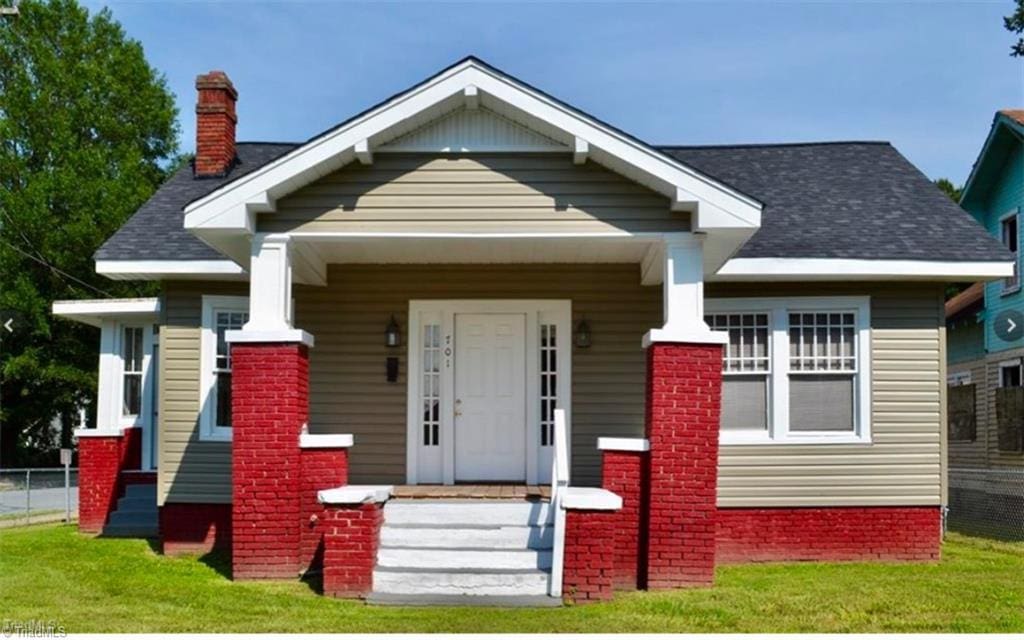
[377,548,551,570]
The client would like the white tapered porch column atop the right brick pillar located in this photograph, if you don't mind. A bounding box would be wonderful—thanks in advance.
[643,233,728,347]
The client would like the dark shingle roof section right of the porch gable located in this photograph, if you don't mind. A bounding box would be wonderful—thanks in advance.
[660,142,1010,261]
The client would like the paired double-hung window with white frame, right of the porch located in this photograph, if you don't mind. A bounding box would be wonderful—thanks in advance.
[705,297,870,444]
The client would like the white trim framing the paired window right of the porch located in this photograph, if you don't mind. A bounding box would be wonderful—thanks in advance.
[705,296,871,444]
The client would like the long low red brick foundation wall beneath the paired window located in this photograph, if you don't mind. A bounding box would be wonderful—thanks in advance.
[717,507,942,563]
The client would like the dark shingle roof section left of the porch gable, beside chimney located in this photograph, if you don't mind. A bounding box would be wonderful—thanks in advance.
[93,142,298,260]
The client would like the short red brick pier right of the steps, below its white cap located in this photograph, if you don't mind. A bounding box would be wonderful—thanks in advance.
[562,510,617,602]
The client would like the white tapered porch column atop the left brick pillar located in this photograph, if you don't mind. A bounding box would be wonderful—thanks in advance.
[234,233,313,346]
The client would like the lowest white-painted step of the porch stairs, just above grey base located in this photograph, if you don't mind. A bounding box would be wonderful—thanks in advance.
[374,567,549,596]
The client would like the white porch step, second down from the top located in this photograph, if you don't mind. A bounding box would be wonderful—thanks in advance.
[381,525,555,549]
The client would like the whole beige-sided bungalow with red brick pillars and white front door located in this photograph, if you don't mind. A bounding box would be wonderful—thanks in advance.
[54,57,1013,603]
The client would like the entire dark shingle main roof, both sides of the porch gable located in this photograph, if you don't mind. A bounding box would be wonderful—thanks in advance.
[95,138,1009,261]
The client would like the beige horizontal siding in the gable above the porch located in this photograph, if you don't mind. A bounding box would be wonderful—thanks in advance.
[257,154,689,233]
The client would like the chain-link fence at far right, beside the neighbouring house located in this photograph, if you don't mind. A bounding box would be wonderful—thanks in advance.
[946,468,1024,541]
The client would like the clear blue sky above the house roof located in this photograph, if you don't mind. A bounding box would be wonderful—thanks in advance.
[87,0,1024,183]
